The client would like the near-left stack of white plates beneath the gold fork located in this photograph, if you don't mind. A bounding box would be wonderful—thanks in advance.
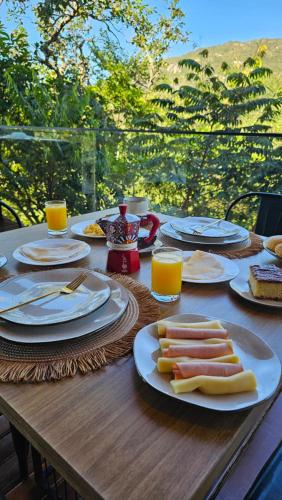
[0,268,128,344]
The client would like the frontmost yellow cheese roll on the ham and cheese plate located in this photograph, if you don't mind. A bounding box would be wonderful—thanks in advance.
[170,370,257,394]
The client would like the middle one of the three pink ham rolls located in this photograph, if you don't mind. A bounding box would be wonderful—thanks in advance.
[163,344,233,359]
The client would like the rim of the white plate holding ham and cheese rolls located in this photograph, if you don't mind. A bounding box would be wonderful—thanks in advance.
[133,313,282,413]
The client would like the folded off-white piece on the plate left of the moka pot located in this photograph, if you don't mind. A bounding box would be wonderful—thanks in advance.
[20,241,84,262]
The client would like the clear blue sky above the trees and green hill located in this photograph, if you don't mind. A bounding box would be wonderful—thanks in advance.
[0,0,282,56]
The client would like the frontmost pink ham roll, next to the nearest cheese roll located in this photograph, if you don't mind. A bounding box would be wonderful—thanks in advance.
[172,361,243,380]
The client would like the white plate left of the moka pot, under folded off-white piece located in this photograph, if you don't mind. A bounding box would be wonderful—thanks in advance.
[13,238,91,266]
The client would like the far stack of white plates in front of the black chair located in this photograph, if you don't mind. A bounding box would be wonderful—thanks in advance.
[160,217,249,245]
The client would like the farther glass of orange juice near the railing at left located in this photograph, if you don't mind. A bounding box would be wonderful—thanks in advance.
[45,200,68,236]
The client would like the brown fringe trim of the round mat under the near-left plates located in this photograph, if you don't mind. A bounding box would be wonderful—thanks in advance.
[0,275,160,383]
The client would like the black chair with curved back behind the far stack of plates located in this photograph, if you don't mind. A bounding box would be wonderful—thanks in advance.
[225,191,282,236]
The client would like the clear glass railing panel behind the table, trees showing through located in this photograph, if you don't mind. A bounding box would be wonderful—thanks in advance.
[0,127,282,232]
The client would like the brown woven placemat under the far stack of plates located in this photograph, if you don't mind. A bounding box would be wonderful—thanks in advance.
[158,233,263,259]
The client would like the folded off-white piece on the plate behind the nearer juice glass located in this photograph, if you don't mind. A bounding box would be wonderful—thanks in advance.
[183,250,224,281]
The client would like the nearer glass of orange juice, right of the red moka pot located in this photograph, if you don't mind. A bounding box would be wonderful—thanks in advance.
[151,247,183,302]
